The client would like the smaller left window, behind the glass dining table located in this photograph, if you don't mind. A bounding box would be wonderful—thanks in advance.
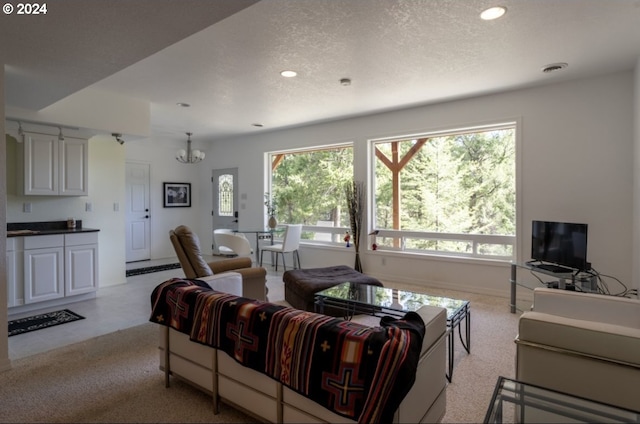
[269,145,353,242]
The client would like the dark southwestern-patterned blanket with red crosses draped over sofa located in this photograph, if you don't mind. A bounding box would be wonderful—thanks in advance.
[150,278,424,422]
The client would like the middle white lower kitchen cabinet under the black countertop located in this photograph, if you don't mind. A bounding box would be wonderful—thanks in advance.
[24,234,64,304]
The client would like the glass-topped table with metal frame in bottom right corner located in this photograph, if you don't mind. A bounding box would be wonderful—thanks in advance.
[484,377,640,423]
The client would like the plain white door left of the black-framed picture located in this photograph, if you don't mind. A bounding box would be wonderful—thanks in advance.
[126,162,151,262]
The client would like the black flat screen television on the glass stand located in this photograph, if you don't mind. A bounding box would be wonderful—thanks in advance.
[531,221,591,271]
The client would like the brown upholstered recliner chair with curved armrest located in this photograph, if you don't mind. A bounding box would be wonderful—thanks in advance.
[169,225,267,300]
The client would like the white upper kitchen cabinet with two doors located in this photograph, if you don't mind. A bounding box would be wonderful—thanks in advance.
[18,135,89,196]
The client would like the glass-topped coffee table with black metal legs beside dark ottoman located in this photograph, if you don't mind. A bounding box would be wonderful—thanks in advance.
[315,282,471,382]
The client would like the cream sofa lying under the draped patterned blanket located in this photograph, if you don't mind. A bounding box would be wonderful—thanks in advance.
[153,273,446,423]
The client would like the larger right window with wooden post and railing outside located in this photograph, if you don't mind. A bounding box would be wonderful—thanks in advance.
[372,123,516,259]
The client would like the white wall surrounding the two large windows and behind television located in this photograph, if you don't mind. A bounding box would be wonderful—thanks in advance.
[208,72,638,296]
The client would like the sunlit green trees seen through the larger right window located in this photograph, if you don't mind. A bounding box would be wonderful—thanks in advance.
[375,129,515,238]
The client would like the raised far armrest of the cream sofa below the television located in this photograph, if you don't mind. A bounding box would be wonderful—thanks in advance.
[533,288,640,328]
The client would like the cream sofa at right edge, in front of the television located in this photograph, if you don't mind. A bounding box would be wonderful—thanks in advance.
[516,288,640,411]
